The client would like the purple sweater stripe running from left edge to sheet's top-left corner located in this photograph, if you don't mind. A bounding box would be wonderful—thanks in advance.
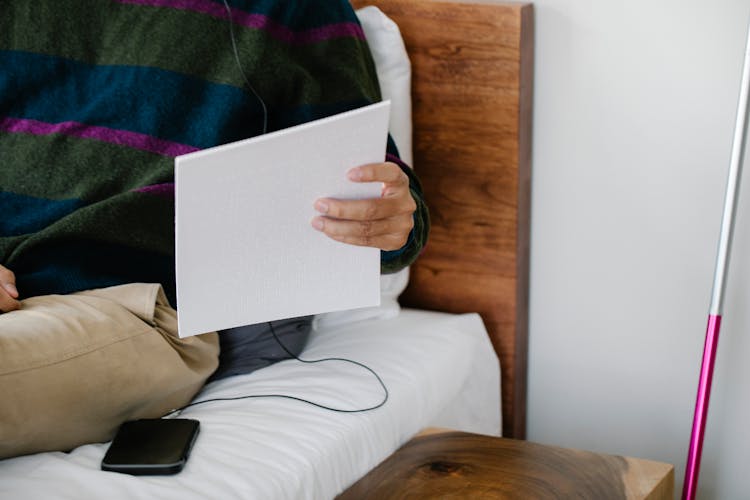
[0,117,200,157]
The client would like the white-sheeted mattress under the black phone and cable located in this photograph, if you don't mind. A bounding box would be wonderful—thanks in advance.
[0,310,501,500]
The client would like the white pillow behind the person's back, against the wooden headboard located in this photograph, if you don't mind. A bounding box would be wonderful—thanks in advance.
[313,6,412,329]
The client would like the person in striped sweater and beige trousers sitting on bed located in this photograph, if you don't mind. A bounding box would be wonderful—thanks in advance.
[0,0,429,458]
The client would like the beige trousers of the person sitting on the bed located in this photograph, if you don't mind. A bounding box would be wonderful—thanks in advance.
[0,283,219,459]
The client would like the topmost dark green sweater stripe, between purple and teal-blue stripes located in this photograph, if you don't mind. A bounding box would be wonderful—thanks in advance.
[0,0,379,107]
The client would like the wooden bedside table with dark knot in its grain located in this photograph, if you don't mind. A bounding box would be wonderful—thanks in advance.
[337,431,674,500]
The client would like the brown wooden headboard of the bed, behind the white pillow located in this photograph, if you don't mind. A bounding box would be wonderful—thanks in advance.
[352,0,534,439]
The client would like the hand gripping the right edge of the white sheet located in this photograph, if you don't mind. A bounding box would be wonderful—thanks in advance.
[312,162,417,250]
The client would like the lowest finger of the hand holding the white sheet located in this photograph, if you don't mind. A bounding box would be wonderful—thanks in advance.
[312,215,414,250]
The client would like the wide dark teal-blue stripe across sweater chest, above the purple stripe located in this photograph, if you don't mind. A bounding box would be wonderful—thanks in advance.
[0,51,261,149]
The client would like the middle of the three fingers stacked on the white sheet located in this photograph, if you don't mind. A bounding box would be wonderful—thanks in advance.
[315,191,417,221]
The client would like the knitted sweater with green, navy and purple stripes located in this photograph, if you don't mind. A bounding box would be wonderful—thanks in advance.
[0,0,429,303]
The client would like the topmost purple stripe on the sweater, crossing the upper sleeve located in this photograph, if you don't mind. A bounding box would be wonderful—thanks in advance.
[116,0,365,44]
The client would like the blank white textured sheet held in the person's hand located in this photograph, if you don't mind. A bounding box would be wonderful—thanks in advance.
[175,101,390,337]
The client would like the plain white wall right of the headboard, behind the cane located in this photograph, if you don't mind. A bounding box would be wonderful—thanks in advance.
[528,0,750,499]
